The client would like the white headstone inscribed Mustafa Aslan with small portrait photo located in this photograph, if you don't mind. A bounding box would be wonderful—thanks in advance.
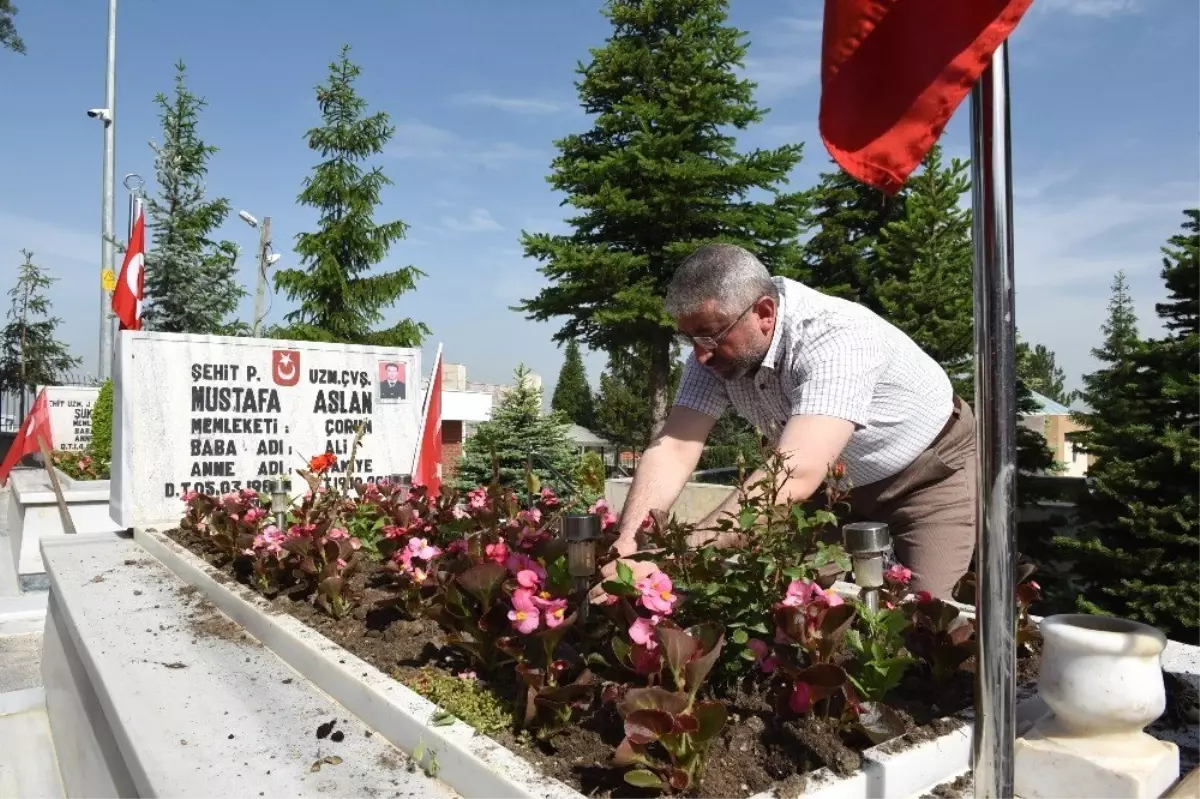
[112,331,422,528]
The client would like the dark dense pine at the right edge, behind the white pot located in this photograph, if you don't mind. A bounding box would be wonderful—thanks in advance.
[1060,210,1200,643]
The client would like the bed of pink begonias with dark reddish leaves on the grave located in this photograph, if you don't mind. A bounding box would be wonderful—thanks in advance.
[169,448,1037,797]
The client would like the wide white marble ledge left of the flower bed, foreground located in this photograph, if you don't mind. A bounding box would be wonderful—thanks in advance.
[43,527,455,799]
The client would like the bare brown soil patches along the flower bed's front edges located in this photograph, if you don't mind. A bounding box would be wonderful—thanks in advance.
[167,529,1040,799]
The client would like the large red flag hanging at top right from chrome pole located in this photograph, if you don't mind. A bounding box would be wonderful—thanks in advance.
[820,0,1032,194]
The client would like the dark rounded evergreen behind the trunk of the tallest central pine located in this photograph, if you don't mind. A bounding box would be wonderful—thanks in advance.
[594,344,683,452]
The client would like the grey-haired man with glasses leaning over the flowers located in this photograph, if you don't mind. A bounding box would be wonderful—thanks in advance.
[614,245,976,597]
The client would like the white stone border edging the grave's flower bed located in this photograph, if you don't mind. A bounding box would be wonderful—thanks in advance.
[134,525,1042,799]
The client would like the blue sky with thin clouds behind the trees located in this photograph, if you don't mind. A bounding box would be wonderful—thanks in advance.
[0,0,1200,398]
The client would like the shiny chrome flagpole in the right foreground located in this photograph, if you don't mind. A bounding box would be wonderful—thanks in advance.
[971,42,1016,799]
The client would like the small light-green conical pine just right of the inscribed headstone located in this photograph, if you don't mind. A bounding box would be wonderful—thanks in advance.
[455,365,580,493]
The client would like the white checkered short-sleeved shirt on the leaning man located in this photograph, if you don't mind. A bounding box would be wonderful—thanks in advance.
[676,277,954,486]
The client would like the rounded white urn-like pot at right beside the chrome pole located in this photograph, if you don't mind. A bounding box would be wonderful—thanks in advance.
[1038,613,1166,735]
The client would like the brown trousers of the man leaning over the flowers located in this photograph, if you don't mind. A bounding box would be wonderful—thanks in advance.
[847,397,978,599]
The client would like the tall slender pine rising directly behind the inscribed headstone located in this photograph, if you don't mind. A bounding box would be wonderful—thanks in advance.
[272,46,430,347]
